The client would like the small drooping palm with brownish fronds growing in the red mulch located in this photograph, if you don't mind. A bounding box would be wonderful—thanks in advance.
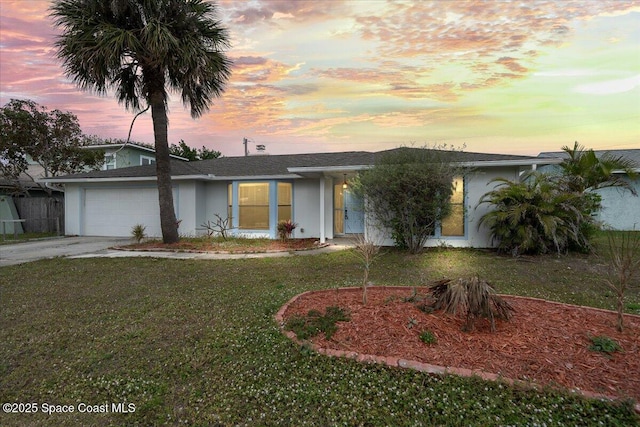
[429,277,514,332]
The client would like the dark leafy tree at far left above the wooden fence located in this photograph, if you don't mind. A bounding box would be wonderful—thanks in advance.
[0,99,104,194]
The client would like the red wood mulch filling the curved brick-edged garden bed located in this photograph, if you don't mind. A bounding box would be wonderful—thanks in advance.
[284,287,640,401]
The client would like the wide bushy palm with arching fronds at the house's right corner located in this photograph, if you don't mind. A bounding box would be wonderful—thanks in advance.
[479,172,593,255]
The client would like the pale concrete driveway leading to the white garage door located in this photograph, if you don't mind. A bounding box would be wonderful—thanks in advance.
[0,237,131,267]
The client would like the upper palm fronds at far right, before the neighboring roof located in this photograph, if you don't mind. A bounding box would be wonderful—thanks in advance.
[560,142,638,196]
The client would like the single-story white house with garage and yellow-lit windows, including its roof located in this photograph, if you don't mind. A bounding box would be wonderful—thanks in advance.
[46,151,559,247]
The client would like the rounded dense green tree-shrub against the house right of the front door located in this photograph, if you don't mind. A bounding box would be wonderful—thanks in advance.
[354,147,461,253]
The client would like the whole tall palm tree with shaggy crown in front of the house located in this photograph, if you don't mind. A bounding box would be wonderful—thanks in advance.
[51,0,231,243]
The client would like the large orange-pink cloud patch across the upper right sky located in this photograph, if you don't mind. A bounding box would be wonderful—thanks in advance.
[354,0,638,88]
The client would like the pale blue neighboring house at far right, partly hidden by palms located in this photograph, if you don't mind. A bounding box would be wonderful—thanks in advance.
[538,149,640,230]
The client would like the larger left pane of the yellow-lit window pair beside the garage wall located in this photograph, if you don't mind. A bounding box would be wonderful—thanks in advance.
[238,182,269,230]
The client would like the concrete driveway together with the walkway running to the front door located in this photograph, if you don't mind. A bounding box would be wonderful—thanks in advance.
[0,237,353,267]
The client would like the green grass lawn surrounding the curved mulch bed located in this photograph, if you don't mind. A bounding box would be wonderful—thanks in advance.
[0,244,640,426]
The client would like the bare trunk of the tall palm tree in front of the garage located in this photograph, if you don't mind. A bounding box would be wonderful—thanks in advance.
[149,91,179,243]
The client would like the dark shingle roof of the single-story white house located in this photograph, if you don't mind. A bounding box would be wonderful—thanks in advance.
[47,148,552,181]
